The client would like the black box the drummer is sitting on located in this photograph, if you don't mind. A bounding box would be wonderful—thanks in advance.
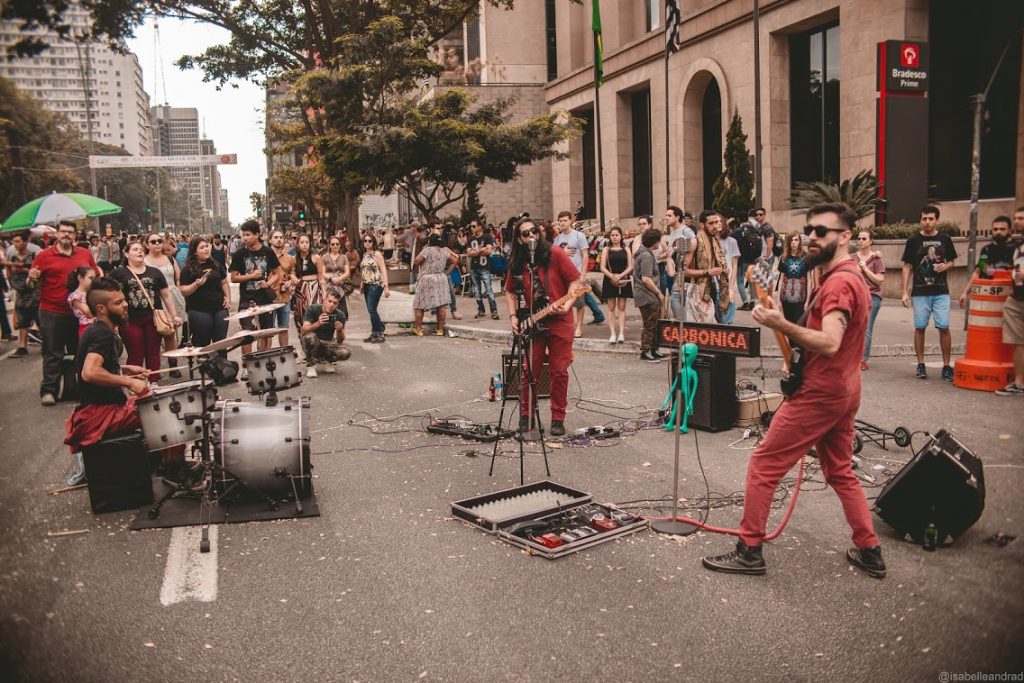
[82,432,153,514]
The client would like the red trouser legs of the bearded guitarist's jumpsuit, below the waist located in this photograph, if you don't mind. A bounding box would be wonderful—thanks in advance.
[739,394,879,549]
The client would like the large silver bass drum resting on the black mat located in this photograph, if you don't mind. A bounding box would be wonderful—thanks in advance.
[214,396,312,498]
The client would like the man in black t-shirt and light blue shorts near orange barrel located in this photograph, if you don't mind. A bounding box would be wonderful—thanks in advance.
[902,206,956,382]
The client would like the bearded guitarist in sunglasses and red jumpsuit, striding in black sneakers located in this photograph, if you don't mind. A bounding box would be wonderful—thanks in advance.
[701,204,886,579]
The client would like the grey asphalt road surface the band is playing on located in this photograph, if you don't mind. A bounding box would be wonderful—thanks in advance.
[0,315,1024,681]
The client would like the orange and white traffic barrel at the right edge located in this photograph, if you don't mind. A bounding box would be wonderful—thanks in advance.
[953,270,1014,391]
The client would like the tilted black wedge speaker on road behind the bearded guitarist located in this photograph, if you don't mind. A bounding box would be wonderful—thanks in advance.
[874,429,985,543]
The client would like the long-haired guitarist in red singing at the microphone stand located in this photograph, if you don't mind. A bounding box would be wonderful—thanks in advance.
[505,216,580,436]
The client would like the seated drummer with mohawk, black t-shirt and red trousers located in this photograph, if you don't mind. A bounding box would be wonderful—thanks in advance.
[65,278,150,458]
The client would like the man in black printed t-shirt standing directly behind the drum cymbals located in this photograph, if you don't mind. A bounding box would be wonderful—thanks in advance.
[228,220,281,358]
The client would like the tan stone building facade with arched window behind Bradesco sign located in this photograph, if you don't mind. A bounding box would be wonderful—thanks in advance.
[538,0,1024,232]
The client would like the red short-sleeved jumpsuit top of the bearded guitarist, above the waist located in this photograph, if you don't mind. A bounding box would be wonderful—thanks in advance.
[801,259,870,397]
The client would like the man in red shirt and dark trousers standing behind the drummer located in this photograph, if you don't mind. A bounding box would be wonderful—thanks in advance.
[27,220,98,405]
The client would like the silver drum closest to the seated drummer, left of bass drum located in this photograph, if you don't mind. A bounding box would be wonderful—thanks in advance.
[135,380,217,451]
